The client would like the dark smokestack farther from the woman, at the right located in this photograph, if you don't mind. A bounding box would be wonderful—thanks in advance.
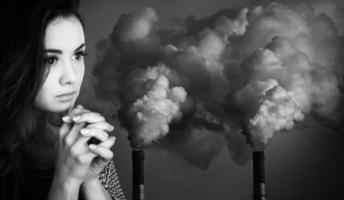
[252,151,267,200]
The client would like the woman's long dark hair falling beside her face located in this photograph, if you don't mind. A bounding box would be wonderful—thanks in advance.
[0,0,83,199]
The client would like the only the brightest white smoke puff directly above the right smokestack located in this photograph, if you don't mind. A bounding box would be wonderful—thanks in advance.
[248,80,304,150]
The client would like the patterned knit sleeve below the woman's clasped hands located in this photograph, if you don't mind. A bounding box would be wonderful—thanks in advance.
[98,160,125,200]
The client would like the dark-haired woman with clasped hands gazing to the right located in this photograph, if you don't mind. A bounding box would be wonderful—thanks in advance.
[0,0,125,200]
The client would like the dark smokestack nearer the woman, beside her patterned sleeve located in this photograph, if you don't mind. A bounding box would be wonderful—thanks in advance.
[132,149,145,200]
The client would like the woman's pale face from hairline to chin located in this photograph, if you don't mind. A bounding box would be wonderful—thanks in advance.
[35,17,86,112]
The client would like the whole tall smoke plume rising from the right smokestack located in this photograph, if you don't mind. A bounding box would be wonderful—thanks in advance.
[228,3,341,150]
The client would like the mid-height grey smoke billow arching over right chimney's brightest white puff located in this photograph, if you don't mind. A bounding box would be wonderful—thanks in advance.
[246,37,313,112]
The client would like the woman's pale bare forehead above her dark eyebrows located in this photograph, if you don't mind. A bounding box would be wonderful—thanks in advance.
[44,16,85,50]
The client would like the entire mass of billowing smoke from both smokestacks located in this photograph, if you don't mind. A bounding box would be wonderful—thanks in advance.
[88,0,344,169]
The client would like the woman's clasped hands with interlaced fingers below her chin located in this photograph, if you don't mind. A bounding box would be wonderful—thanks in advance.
[55,105,115,183]
